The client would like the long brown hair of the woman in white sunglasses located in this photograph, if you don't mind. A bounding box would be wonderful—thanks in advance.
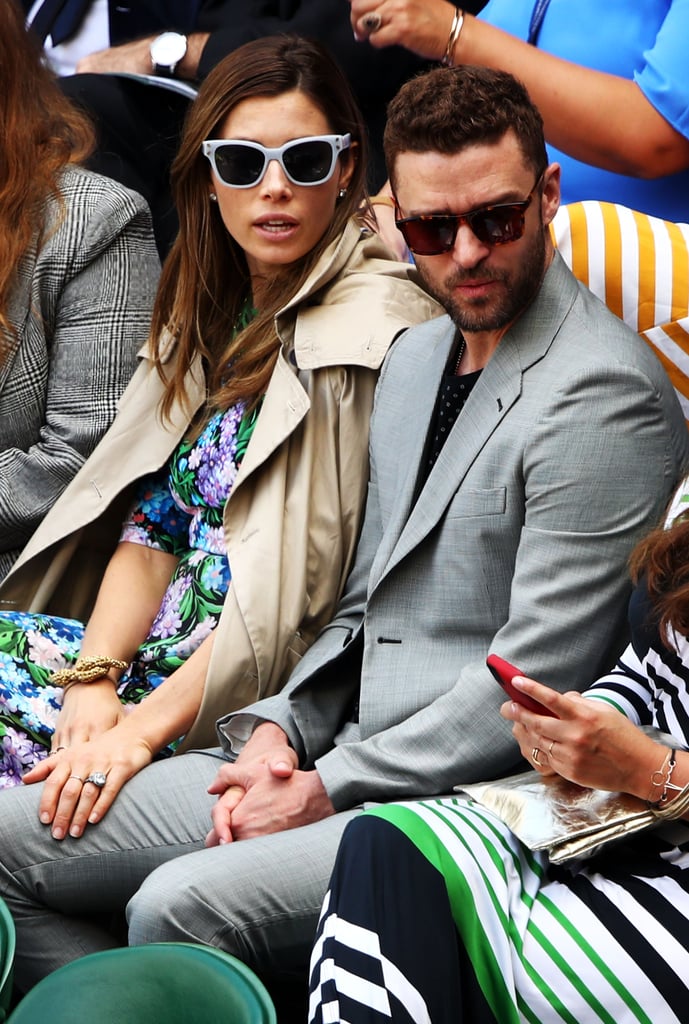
[150,35,365,418]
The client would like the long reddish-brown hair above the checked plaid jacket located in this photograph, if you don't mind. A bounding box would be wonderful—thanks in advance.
[0,0,94,344]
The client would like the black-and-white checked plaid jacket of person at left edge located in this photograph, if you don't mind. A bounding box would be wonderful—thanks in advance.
[0,167,160,580]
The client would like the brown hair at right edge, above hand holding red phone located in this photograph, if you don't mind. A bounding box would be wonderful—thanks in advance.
[630,509,689,644]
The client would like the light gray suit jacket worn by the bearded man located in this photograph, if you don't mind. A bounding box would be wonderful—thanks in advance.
[219,256,689,810]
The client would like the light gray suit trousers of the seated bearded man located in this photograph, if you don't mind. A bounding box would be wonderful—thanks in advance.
[0,750,358,990]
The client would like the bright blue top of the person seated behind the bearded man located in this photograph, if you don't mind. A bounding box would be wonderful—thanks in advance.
[479,0,689,221]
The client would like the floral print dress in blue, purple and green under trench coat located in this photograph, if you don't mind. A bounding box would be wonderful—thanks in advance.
[0,402,258,788]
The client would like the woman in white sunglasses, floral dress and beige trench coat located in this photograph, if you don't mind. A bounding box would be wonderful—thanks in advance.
[0,29,441,815]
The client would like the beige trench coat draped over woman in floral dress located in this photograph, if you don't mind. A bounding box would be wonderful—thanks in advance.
[0,222,442,749]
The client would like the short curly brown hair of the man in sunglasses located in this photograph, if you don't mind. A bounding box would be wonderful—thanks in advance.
[384,65,548,187]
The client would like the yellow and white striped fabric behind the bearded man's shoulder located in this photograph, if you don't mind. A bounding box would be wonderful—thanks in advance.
[551,200,689,421]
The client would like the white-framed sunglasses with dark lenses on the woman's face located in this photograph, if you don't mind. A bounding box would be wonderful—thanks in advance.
[201,133,351,188]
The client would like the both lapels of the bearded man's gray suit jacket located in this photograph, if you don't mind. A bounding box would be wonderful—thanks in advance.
[371,253,577,590]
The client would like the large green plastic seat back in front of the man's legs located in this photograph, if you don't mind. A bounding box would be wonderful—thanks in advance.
[9,942,276,1024]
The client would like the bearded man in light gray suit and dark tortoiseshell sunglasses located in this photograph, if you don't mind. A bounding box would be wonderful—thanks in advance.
[0,68,688,999]
